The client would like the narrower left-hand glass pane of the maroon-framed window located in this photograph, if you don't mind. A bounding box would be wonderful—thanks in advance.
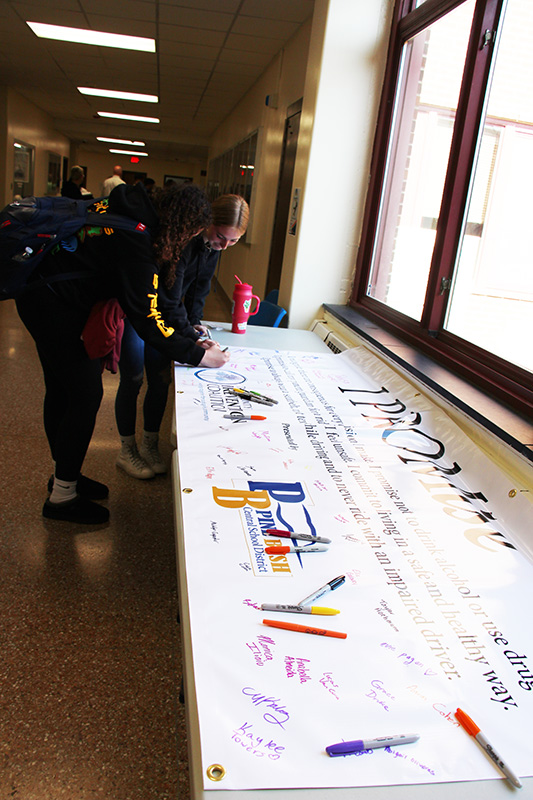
[367,0,474,320]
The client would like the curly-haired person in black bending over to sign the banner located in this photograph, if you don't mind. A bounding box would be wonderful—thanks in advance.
[17,185,229,524]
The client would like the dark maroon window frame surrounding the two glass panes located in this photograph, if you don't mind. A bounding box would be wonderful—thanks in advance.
[350,0,533,415]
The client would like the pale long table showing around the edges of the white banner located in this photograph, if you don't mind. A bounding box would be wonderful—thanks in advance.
[172,325,533,800]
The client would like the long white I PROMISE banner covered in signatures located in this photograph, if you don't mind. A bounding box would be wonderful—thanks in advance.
[175,347,533,790]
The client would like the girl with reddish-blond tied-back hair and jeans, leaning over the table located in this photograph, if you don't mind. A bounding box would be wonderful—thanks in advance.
[115,194,250,479]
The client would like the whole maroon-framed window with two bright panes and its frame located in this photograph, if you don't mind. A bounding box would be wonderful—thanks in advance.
[352,0,533,413]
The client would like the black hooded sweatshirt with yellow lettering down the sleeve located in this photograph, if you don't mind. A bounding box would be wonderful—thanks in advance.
[34,184,205,366]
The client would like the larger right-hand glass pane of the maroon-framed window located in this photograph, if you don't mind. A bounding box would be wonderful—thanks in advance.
[445,0,533,370]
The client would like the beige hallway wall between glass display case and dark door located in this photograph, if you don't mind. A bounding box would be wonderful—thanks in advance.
[205,22,311,306]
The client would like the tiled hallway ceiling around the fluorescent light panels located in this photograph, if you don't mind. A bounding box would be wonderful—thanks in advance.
[0,0,314,161]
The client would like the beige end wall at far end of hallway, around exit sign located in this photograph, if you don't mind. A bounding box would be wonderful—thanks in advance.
[70,145,207,197]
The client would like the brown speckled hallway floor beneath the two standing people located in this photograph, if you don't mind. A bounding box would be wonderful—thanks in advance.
[0,288,227,800]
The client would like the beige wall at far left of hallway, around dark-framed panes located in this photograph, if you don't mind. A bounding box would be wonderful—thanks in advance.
[2,89,70,206]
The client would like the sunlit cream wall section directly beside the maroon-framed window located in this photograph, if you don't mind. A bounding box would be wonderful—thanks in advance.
[280,0,393,328]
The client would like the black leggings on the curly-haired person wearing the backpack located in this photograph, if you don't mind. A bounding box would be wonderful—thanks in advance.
[17,286,103,481]
